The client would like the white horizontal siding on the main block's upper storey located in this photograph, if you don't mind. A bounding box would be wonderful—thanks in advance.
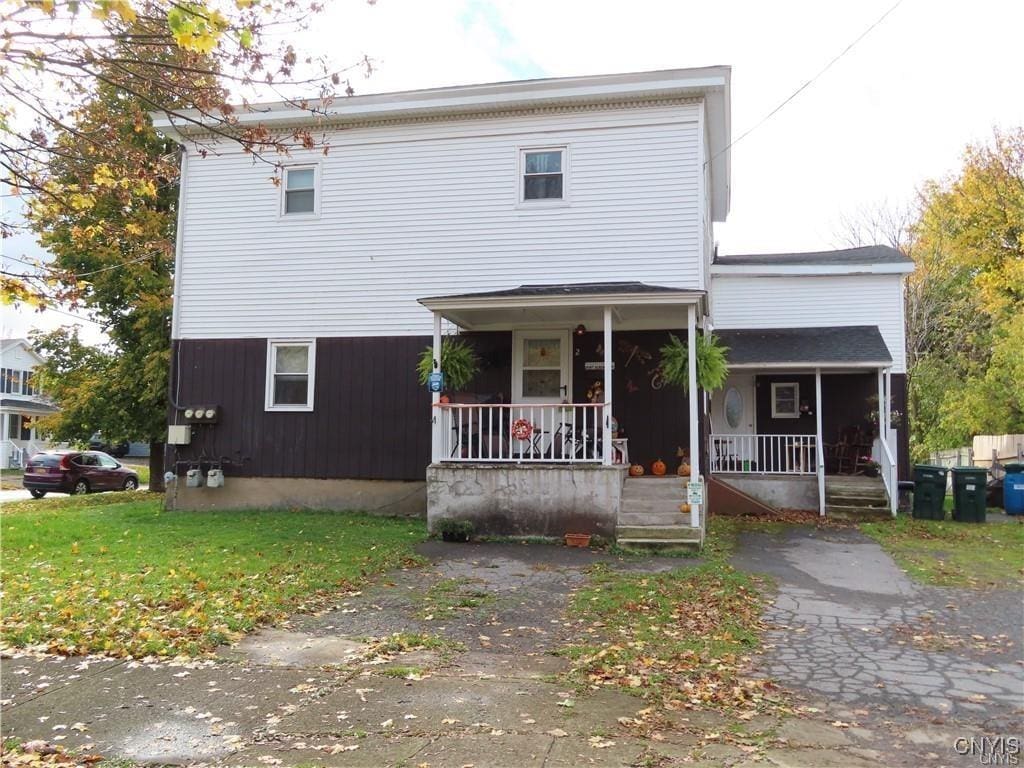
[176,104,701,338]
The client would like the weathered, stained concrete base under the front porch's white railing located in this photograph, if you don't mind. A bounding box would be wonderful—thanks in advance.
[427,464,625,539]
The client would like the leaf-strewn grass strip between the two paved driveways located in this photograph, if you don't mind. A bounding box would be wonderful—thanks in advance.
[563,517,774,709]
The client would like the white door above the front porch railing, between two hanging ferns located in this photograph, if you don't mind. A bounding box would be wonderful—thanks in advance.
[512,331,572,403]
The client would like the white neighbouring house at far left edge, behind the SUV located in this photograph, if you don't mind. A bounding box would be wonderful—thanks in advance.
[0,339,57,469]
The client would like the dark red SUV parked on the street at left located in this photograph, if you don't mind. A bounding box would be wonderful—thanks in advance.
[22,451,138,499]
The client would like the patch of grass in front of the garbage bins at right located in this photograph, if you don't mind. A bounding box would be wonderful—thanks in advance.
[860,512,1024,588]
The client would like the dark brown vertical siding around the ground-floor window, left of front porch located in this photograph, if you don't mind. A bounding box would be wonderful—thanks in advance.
[169,336,430,480]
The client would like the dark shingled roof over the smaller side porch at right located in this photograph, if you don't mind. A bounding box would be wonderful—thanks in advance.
[715,326,893,368]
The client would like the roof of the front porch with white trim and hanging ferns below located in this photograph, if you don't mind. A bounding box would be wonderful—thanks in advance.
[419,282,705,331]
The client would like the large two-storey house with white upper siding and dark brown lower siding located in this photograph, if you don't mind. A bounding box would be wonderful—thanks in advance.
[155,67,909,540]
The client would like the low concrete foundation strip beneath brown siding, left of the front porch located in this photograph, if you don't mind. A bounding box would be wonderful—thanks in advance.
[167,477,427,517]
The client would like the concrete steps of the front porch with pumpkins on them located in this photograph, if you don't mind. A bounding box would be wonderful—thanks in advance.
[615,476,700,550]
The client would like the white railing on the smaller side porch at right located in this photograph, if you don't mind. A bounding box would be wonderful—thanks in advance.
[709,434,818,475]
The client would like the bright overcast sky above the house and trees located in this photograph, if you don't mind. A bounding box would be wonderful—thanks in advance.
[3,0,1024,342]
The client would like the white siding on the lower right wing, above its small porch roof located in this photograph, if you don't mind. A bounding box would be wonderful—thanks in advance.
[711,274,906,374]
